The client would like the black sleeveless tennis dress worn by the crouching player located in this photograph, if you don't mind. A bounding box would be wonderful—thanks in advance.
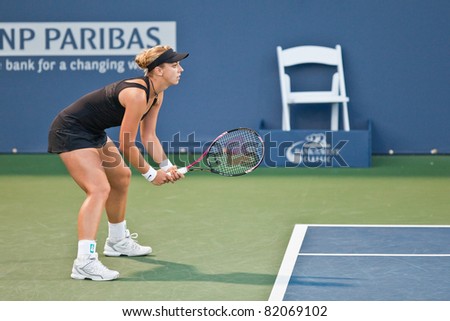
[48,77,156,154]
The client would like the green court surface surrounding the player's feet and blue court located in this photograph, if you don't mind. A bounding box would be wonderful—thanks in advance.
[0,154,450,301]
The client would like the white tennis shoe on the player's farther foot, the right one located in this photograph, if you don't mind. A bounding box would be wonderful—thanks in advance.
[103,230,152,256]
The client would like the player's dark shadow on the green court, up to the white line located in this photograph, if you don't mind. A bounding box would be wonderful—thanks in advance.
[118,256,275,285]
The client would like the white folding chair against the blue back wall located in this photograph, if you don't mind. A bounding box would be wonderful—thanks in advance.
[277,45,350,131]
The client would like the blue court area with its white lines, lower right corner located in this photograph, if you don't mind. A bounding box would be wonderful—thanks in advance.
[269,225,450,301]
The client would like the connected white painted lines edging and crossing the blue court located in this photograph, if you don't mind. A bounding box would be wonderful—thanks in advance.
[269,224,450,301]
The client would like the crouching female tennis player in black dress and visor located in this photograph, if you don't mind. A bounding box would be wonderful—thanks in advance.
[48,46,189,281]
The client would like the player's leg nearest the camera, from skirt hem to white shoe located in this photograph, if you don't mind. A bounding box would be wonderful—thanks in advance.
[60,148,119,281]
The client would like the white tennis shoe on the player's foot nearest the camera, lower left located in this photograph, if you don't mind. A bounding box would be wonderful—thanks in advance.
[70,253,119,281]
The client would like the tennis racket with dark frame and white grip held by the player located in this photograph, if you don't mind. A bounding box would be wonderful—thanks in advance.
[178,128,264,176]
